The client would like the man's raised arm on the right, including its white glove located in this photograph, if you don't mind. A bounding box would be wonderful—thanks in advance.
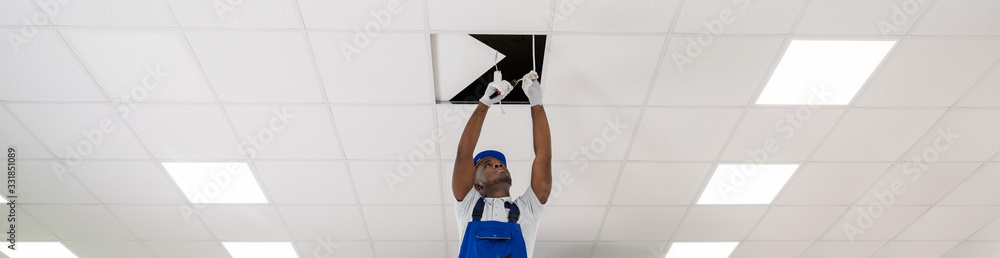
[521,71,552,204]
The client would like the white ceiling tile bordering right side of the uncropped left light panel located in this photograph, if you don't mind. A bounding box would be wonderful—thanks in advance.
[254,160,358,204]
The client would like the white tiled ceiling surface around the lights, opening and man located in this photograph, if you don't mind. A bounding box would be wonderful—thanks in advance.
[0,0,1000,258]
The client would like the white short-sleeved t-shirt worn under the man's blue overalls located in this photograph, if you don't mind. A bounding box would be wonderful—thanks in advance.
[455,186,544,258]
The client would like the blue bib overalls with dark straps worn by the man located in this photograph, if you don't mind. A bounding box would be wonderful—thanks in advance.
[458,197,528,258]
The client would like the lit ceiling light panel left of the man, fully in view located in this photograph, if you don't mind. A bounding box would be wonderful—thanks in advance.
[163,162,267,203]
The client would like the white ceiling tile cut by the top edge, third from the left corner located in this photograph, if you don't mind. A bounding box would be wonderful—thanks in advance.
[167,0,302,28]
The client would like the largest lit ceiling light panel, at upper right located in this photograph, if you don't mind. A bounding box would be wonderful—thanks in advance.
[757,40,896,105]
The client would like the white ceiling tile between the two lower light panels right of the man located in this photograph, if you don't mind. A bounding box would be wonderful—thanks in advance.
[672,205,767,241]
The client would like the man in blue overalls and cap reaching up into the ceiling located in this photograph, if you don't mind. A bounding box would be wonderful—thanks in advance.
[451,71,552,258]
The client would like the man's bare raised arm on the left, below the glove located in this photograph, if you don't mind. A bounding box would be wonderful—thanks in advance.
[451,103,490,201]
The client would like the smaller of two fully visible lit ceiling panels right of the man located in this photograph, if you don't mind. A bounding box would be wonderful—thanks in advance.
[698,164,799,204]
